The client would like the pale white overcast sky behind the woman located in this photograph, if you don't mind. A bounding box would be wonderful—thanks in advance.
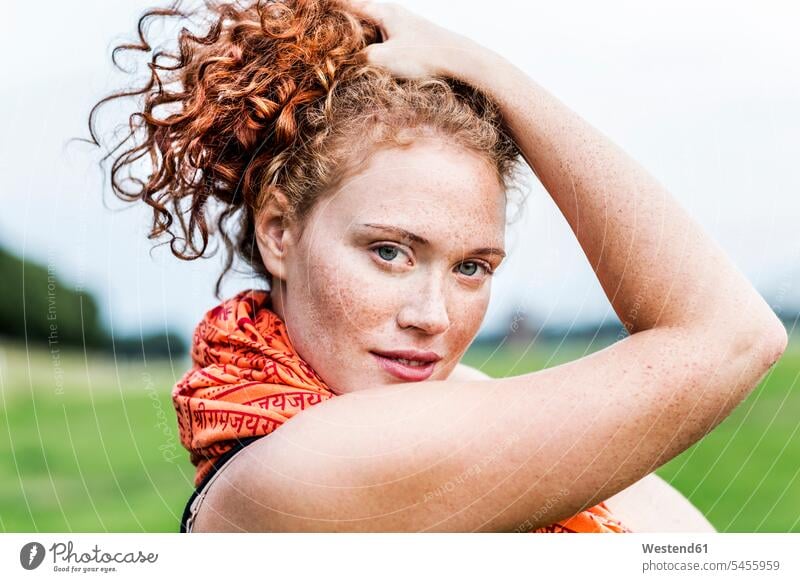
[0,0,800,342]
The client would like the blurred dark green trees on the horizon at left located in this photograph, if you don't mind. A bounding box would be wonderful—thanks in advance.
[0,247,187,358]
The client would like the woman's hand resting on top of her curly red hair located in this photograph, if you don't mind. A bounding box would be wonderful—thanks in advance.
[349,0,487,79]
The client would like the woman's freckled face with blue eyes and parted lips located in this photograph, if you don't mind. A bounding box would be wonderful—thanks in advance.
[272,138,506,394]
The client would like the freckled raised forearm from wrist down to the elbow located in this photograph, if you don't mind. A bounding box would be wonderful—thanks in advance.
[449,50,780,350]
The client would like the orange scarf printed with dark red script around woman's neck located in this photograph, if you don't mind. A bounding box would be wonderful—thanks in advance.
[172,290,630,533]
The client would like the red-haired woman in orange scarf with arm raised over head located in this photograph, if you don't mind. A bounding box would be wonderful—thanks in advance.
[86,0,787,532]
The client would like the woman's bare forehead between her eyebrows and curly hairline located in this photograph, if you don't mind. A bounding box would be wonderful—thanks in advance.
[321,138,506,246]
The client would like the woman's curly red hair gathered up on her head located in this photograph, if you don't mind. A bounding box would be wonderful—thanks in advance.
[89,0,519,298]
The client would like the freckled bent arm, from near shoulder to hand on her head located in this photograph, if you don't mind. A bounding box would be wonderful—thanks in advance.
[195,3,787,531]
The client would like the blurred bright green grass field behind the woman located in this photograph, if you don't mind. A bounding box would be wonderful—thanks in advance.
[0,341,800,532]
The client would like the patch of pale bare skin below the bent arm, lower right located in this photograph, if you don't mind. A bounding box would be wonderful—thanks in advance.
[606,473,716,533]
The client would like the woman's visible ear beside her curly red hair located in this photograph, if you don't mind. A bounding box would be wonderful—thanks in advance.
[255,188,294,281]
